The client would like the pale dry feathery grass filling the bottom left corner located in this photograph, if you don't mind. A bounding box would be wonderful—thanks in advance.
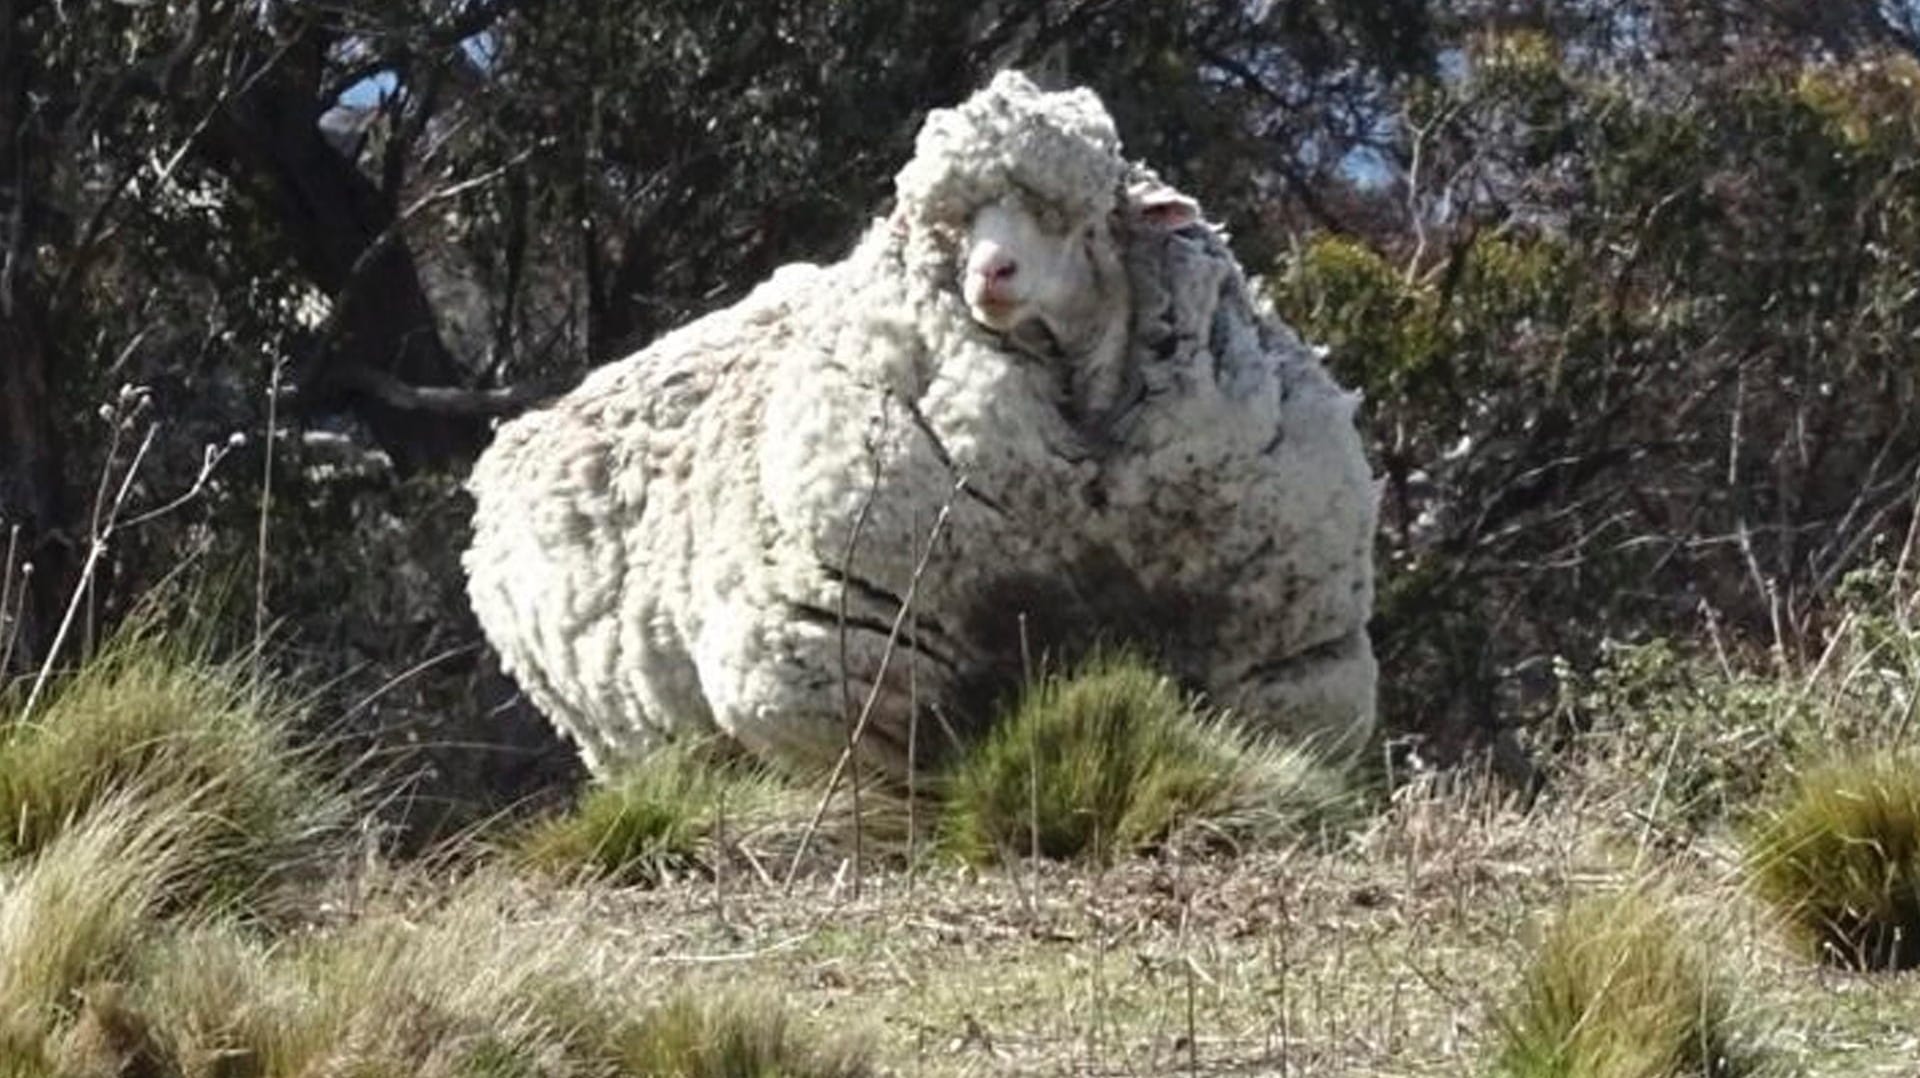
[0,799,868,1078]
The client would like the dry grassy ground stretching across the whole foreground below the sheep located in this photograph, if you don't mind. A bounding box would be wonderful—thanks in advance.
[8,710,1920,1078]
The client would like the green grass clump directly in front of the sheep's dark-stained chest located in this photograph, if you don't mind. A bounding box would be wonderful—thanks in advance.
[941,651,1344,861]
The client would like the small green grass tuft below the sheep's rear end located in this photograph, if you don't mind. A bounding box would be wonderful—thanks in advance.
[511,740,795,884]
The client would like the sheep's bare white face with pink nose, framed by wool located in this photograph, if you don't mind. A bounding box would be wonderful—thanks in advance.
[960,196,1125,352]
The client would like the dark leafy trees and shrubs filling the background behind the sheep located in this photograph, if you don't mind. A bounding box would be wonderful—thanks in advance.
[11,0,1920,799]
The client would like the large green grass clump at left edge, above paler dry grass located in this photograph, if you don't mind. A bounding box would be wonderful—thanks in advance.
[0,626,348,897]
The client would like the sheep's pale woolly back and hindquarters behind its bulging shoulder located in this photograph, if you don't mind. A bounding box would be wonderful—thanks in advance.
[465,265,822,771]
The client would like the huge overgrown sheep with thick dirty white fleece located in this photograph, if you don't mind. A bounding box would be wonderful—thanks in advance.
[465,73,1375,772]
